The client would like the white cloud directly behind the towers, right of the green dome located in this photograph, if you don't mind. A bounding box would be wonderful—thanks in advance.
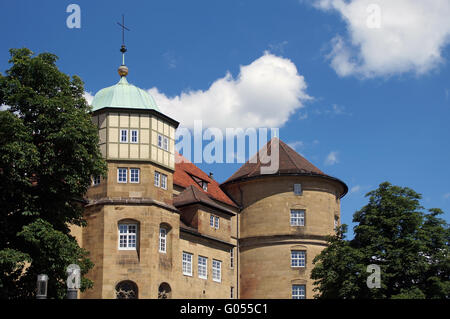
[149,52,311,129]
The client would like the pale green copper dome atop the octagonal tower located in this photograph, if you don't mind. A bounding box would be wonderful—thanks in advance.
[92,75,159,111]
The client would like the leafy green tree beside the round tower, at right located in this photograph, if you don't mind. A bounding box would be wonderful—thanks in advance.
[311,182,450,299]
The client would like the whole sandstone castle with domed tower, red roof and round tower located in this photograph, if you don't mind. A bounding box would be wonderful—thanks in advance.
[72,55,347,299]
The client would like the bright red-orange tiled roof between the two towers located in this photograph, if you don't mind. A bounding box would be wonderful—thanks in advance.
[173,152,237,207]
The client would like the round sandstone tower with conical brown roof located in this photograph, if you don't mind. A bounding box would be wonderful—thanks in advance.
[222,138,348,299]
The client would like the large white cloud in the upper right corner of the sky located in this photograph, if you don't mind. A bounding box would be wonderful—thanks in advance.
[312,0,450,77]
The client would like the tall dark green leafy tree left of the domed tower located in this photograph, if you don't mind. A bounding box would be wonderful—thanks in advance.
[0,48,106,298]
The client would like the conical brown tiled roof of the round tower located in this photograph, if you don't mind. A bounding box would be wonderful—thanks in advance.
[222,137,347,196]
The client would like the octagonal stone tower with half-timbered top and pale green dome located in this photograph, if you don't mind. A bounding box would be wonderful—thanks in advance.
[77,66,181,298]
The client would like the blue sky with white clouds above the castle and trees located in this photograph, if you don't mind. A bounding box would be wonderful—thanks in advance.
[0,0,450,237]
